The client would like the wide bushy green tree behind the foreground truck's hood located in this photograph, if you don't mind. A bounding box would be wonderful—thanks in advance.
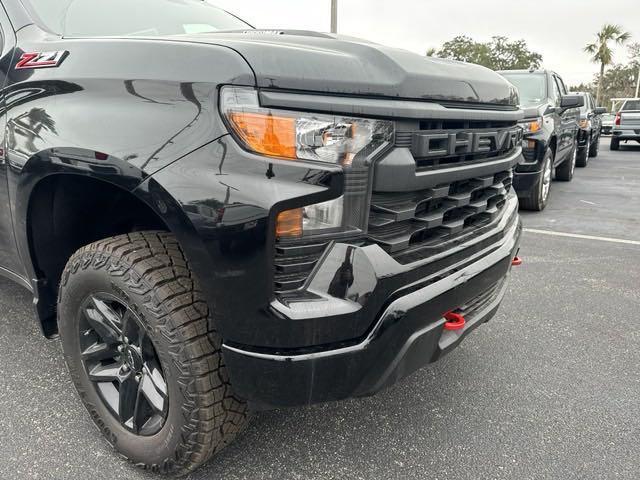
[427,35,542,70]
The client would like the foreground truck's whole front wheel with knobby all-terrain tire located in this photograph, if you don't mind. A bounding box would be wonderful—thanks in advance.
[58,232,248,475]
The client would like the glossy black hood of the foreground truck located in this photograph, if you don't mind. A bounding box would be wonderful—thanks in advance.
[172,30,518,107]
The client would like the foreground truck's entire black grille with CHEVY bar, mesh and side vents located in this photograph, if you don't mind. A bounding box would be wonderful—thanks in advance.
[274,120,522,294]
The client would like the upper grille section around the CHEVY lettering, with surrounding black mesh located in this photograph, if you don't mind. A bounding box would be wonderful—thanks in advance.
[395,120,522,170]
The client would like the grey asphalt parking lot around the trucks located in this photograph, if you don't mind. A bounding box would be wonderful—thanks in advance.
[0,139,640,480]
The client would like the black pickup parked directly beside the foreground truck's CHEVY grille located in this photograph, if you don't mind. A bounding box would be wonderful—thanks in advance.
[498,70,584,211]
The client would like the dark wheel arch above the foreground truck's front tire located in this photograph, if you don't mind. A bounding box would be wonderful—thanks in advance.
[13,148,208,337]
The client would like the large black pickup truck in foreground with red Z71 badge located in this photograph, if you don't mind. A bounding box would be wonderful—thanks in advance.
[0,0,522,475]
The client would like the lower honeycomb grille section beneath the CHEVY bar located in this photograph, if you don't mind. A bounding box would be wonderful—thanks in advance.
[369,171,513,263]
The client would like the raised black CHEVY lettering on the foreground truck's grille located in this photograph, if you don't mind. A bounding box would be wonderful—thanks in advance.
[411,127,522,158]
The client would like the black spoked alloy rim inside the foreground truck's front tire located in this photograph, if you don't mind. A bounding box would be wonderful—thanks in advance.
[78,293,169,436]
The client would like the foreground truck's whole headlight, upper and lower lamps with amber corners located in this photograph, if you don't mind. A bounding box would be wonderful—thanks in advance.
[220,87,395,239]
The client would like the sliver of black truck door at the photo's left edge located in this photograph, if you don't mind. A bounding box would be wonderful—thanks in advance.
[0,6,24,276]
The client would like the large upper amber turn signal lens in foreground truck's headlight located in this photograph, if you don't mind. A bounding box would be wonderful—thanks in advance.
[229,112,296,158]
